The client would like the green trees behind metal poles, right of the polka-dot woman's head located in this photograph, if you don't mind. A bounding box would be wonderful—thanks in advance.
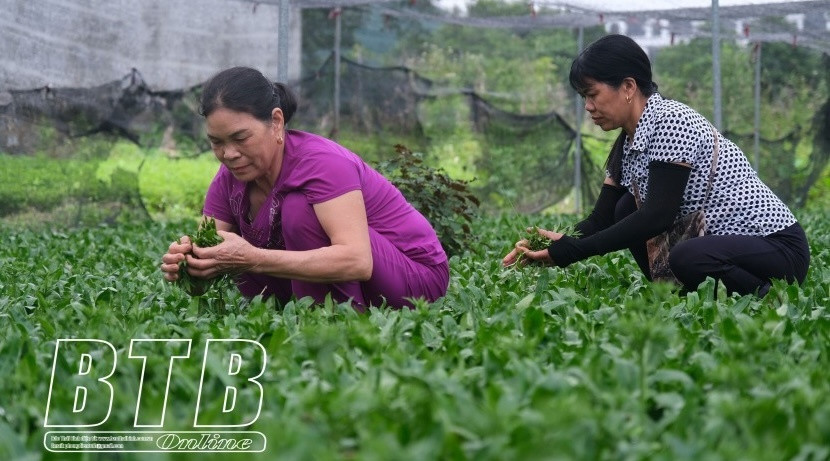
[655,39,828,205]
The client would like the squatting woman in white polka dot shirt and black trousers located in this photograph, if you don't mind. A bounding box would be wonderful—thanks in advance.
[503,35,810,296]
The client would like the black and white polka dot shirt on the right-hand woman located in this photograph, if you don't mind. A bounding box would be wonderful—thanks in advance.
[621,93,796,236]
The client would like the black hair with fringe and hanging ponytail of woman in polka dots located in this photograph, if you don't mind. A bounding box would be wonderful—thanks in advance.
[569,34,657,183]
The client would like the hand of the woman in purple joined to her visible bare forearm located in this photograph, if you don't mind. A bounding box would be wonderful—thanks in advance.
[187,231,256,279]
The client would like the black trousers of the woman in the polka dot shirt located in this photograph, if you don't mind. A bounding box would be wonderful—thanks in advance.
[614,193,810,296]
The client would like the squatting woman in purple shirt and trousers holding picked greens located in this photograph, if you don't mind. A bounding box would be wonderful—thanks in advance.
[161,67,449,308]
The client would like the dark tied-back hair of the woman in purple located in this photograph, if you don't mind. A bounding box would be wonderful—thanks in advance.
[199,67,297,123]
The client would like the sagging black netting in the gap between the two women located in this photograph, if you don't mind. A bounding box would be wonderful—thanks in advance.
[292,54,602,212]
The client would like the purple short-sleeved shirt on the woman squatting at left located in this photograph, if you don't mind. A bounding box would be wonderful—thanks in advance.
[203,130,447,265]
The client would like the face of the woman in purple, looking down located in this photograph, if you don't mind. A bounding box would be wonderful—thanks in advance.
[205,108,282,182]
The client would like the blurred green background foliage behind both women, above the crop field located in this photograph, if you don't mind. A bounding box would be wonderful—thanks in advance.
[0,0,830,228]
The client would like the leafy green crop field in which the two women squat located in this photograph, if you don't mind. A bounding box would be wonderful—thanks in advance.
[0,212,830,461]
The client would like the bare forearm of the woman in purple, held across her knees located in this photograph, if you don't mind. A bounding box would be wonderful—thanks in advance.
[249,245,372,283]
